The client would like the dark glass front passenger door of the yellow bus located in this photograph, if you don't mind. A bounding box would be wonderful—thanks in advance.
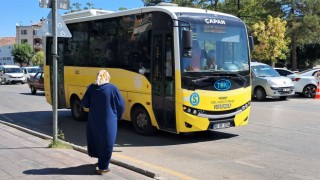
[151,33,177,132]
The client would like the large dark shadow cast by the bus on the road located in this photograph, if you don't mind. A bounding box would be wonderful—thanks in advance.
[0,110,238,147]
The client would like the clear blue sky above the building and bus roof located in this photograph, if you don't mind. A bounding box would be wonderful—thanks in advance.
[0,0,143,38]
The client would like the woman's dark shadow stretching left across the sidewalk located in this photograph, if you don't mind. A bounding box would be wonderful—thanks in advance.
[23,164,95,175]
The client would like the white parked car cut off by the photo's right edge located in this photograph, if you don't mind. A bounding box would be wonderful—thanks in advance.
[275,68,320,98]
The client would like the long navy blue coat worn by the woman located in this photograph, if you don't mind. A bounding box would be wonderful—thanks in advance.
[81,83,124,169]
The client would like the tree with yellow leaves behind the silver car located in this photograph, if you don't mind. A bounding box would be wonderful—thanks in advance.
[252,16,289,67]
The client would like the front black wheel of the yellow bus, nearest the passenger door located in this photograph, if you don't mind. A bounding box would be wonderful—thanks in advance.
[131,106,156,136]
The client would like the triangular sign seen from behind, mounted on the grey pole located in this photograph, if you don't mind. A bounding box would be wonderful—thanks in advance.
[37,11,72,38]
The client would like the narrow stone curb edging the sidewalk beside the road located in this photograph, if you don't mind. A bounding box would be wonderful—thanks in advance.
[0,120,156,179]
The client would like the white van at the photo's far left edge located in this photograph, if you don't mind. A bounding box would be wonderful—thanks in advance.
[0,65,25,84]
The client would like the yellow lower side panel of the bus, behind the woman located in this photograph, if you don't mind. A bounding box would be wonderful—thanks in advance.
[45,66,158,127]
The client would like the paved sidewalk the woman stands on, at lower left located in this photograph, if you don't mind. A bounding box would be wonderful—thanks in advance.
[0,122,152,180]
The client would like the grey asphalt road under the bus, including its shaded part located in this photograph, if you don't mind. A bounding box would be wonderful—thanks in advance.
[0,84,320,180]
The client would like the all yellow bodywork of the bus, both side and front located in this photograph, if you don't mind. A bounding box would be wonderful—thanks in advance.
[44,66,251,133]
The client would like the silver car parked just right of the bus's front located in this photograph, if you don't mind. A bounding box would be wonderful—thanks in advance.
[250,62,295,101]
